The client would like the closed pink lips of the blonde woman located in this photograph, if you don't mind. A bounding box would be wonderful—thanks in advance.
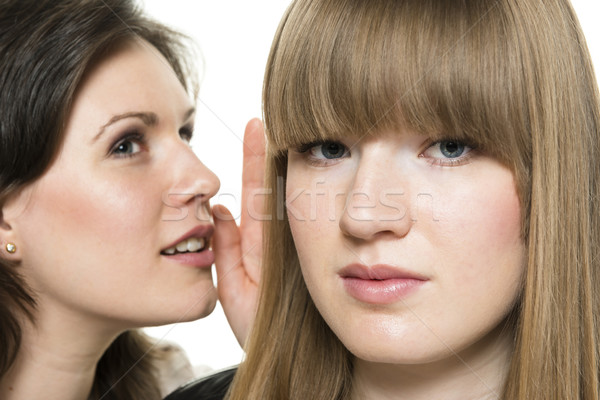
[338,264,427,304]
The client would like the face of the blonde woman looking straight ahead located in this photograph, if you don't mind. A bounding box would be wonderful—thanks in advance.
[286,131,524,364]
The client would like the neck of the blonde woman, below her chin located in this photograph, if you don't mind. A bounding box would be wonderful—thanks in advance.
[352,324,513,400]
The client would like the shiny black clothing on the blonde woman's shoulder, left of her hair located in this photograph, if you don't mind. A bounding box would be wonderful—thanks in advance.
[165,368,237,400]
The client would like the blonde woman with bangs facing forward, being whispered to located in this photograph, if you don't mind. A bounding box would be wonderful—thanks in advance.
[166,0,600,400]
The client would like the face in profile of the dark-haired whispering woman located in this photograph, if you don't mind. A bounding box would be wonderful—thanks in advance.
[5,41,219,328]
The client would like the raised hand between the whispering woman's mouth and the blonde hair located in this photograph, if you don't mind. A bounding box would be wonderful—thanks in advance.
[213,119,265,347]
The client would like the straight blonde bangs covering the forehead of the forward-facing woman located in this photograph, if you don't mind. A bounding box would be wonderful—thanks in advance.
[264,0,529,169]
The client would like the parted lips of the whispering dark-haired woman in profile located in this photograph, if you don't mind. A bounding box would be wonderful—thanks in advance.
[160,225,215,268]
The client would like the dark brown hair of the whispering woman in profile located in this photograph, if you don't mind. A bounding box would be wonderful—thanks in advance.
[0,0,196,399]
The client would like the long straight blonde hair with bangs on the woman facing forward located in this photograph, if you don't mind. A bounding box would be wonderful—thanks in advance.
[229,0,600,400]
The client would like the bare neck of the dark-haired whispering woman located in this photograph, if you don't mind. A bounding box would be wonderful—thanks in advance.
[0,304,118,400]
